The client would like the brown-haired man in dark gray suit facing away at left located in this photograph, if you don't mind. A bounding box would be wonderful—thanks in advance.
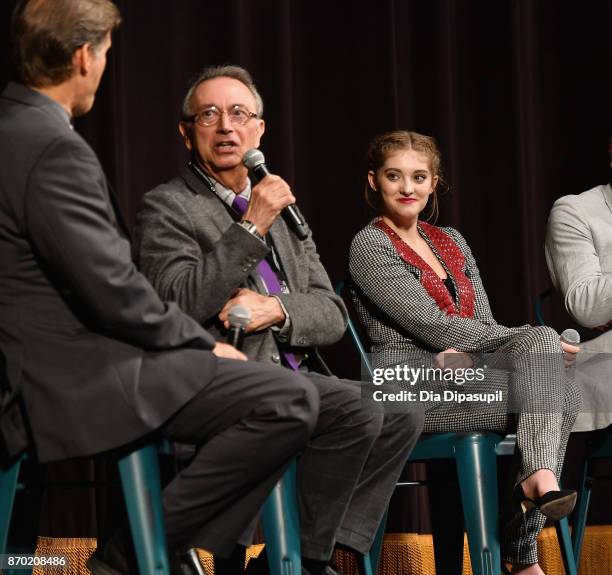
[0,0,319,575]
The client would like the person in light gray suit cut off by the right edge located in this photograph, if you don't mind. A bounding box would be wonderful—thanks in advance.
[546,136,612,431]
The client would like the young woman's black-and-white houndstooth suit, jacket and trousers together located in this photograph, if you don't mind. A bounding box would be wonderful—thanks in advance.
[349,220,580,564]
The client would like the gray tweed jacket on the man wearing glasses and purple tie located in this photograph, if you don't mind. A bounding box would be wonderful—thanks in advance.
[136,168,347,363]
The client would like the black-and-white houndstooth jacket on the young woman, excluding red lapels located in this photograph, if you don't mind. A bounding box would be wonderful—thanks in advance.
[349,220,530,365]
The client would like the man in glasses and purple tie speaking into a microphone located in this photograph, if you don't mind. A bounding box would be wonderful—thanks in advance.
[138,66,422,574]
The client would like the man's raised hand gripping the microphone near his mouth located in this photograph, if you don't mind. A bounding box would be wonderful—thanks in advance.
[244,174,295,236]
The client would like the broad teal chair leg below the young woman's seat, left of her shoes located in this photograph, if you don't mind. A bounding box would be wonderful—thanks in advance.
[455,434,501,575]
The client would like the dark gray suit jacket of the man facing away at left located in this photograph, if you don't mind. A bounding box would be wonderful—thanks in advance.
[0,84,216,460]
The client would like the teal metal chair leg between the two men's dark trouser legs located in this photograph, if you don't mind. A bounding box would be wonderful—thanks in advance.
[262,460,302,575]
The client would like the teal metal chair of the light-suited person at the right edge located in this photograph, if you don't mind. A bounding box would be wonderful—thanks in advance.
[533,288,612,575]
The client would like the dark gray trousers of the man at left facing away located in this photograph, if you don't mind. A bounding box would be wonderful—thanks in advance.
[155,351,319,557]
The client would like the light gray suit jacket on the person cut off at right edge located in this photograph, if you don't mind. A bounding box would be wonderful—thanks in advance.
[546,184,612,327]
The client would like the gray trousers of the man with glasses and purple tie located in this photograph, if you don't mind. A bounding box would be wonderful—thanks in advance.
[298,370,423,560]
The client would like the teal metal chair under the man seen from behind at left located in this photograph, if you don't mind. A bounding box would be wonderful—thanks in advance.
[0,444,170,575]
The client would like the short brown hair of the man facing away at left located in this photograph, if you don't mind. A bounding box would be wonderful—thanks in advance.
[11,0,121,88]
